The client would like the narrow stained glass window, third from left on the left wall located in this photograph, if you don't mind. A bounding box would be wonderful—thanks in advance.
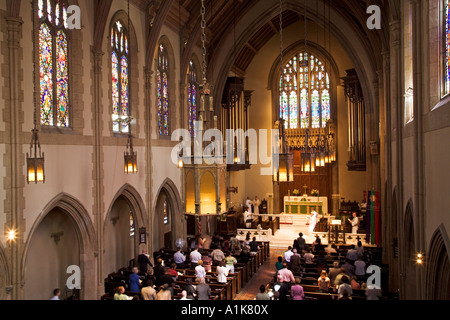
[156,44,169,136]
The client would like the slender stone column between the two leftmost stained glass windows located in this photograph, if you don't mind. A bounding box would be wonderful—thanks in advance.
[92,48,104,296]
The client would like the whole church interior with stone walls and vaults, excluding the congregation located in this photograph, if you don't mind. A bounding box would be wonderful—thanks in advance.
[0,0,450,300]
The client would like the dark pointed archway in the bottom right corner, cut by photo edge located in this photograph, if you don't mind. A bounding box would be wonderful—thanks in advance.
[426,225,450,300]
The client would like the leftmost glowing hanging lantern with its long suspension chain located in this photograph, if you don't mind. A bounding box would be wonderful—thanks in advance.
[27,4,45,184]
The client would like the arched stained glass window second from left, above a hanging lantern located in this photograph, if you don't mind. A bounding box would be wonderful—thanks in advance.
[111,20,130,133]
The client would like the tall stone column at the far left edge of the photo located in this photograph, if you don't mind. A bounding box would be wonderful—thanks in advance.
[3,17,25,300]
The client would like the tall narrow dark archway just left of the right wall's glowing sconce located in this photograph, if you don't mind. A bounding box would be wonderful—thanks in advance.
[403,201,417,300]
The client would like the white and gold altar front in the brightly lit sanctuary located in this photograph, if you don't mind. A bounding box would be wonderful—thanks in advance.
[283,196,328,215]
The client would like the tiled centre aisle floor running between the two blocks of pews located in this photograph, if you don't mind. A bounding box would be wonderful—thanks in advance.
[235,249,286,300]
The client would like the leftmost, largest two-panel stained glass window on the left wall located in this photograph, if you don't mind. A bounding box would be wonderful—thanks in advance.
[37,0,70,127]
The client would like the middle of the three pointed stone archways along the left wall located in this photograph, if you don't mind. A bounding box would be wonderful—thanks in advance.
[103,185,147,276]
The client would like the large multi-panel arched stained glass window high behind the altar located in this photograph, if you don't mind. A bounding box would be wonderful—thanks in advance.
[280,52,331,129]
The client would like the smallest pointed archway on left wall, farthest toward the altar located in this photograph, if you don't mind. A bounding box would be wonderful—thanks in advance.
[153,179,186,251]
